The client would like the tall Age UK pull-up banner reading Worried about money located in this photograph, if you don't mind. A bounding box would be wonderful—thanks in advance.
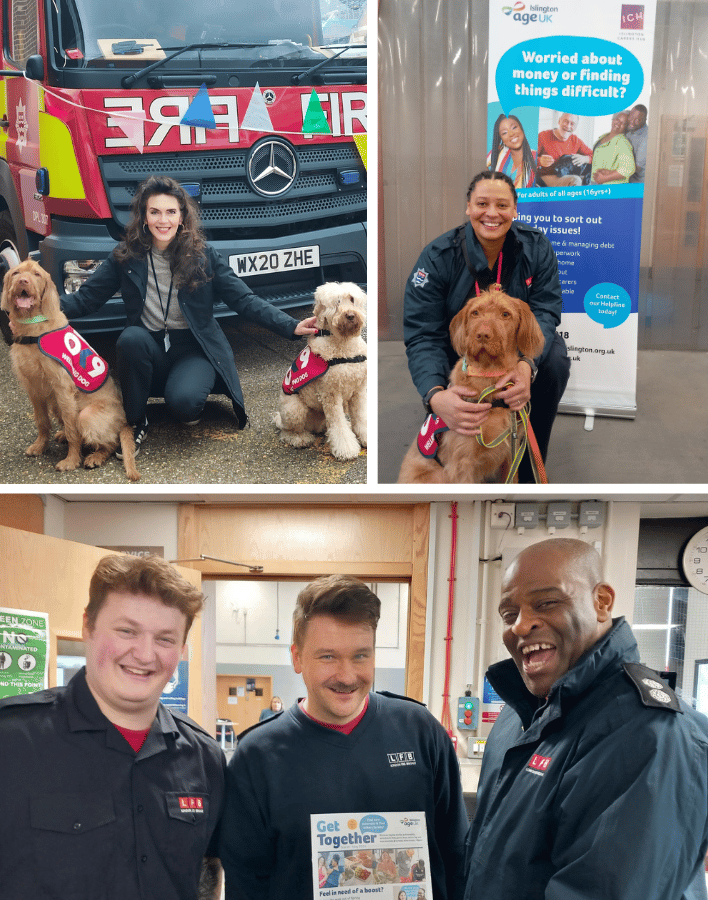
[487,0,656,418]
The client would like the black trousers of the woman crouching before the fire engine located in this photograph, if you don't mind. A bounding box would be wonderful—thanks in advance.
[116,325,217,425]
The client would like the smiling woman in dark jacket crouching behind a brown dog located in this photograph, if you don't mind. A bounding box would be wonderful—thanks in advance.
[404,171,570,482]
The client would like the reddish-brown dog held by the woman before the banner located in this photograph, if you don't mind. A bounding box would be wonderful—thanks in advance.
[398,290,544,484]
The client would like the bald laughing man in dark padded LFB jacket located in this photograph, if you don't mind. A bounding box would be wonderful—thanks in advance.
[464,539,708,900]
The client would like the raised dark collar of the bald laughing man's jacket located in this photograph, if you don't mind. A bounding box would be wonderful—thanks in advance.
[487,616,639,728]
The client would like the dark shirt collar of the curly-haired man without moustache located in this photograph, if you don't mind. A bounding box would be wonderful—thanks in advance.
[64,666,179,759]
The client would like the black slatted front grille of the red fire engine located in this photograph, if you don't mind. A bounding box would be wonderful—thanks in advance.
[100,143,366,232]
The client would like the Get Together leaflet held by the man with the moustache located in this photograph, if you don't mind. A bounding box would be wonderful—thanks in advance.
[310,812,433,900]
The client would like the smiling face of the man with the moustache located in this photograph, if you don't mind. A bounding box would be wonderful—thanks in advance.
[290,615,375,725]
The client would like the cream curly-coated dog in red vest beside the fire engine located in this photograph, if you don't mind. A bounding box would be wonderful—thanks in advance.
[275,282,366,459]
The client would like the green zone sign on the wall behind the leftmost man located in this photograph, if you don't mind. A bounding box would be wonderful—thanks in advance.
[0,606,49,697]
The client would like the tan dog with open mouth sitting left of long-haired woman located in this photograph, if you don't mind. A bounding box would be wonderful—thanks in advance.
[0,259,140,481]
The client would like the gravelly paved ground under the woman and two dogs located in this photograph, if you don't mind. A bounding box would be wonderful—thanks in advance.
[0,308,366,486]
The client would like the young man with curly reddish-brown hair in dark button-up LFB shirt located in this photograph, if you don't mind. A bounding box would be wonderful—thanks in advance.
[0,555,225,900]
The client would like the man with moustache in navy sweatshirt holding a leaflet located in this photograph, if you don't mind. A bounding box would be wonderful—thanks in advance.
[219,575,467,900]
